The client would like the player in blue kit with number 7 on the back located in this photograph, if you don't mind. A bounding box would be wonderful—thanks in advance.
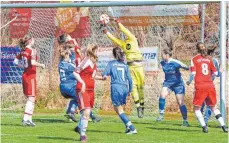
[102,47,137,134]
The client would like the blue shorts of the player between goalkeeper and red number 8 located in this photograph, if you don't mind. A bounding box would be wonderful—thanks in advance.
[163,82,185,95]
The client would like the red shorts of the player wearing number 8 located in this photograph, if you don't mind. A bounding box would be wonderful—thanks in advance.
[193,88,217,107]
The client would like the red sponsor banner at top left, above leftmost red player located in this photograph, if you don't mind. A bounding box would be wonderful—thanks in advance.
[10,8,31,38]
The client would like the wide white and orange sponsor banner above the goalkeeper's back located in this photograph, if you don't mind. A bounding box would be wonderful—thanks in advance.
[109,4,200,26]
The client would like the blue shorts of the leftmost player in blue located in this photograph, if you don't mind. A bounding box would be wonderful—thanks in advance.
[60,83,76,99]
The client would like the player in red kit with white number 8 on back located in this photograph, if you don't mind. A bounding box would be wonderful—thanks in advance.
[191,42,228,133]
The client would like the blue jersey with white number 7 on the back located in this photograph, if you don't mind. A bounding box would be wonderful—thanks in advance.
[102,60,132,92]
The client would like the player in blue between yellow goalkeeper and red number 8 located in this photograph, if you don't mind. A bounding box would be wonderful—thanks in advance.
[156,49,189,126]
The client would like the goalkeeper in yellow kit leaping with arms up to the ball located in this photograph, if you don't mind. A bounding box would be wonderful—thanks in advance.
[103,18,145,118]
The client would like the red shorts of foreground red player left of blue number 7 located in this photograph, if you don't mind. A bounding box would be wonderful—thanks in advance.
[77,90,95,110]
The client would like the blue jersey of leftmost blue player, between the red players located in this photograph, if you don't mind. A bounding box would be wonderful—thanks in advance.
[58,60,76,83]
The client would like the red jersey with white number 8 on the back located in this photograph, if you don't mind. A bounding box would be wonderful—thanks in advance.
[191,54,217,89]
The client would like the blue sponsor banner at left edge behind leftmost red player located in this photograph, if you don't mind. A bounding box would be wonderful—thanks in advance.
[0,47,24,83]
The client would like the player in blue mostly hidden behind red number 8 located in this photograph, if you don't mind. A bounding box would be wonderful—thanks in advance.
[186,46,221,124]
